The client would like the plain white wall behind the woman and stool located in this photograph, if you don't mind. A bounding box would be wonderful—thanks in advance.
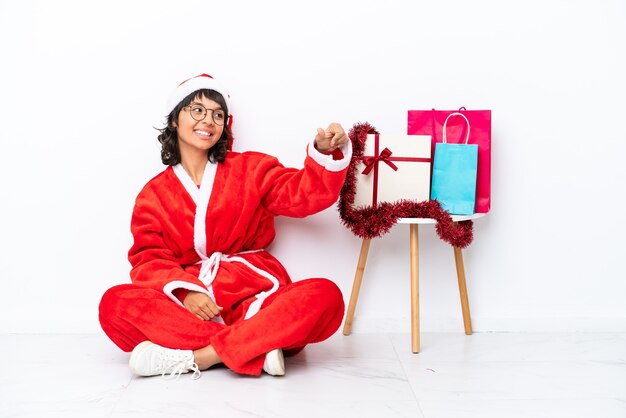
[0,0,626,332]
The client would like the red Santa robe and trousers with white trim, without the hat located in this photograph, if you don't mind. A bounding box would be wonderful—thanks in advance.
[100,142,352,375]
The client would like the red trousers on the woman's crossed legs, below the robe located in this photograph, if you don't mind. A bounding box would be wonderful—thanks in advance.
[100,279,344,376]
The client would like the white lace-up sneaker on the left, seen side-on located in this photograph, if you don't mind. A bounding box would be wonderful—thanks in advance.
[128,341,200,379]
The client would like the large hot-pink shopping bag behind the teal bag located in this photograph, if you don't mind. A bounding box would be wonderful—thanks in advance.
[407,107,491,213]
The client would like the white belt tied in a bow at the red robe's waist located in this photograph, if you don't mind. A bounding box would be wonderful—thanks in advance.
[198,250,278,320]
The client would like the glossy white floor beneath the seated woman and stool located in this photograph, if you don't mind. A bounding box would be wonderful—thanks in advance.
[0,332,626,418]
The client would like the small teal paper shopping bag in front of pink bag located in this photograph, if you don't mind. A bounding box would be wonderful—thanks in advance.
[430,112,478,215]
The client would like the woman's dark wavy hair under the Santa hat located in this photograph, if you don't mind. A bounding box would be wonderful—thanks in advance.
[157,89,233,165]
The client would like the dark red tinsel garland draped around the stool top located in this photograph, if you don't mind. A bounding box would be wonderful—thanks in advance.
[339,122,473,248]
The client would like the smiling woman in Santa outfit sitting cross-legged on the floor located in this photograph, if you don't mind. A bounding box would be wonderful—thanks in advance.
[100,74,352,377]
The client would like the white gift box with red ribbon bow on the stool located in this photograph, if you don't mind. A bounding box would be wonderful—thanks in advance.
[354,134,432,207]
